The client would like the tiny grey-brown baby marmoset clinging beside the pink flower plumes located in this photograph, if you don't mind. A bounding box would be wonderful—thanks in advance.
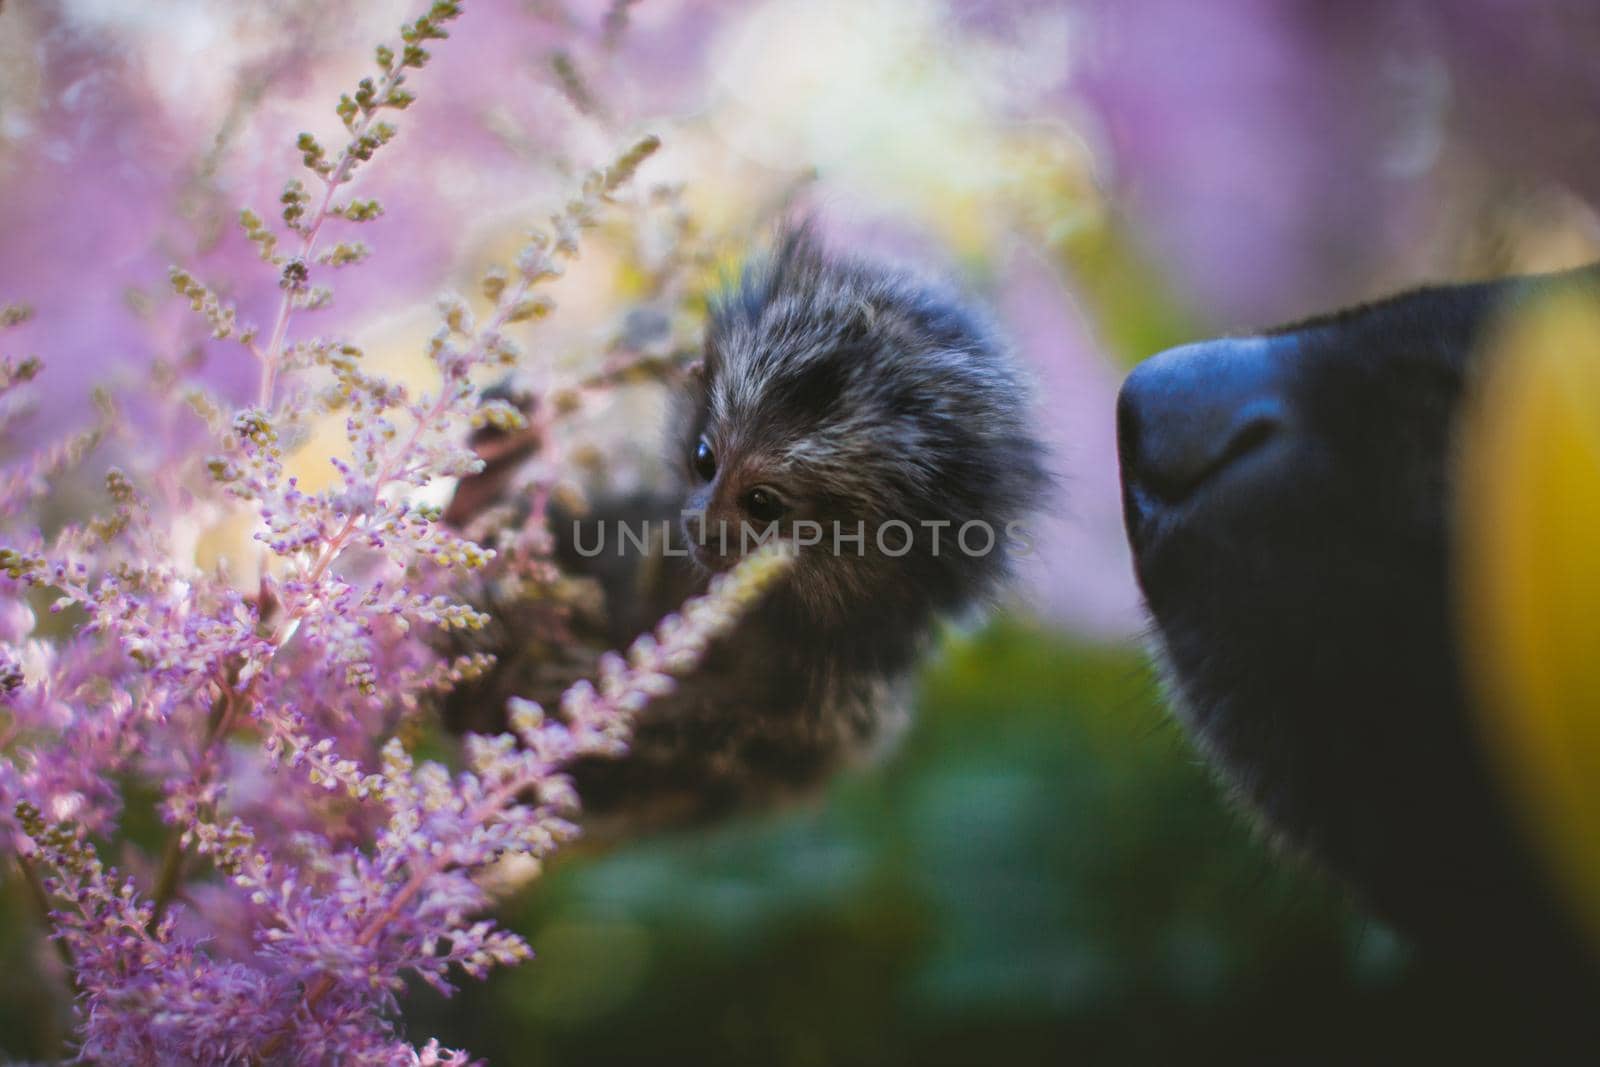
[446,227,1048,829]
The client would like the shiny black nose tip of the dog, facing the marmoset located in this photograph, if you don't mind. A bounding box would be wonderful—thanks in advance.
[1117,338,1293,501]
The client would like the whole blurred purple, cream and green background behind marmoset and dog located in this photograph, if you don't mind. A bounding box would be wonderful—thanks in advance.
[0,0,1600,1065]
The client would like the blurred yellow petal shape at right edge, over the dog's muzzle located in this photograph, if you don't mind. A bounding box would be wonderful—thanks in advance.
[1459,287,1600,937]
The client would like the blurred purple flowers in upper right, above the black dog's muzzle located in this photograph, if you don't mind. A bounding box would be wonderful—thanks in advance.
[1072,0,1600,330]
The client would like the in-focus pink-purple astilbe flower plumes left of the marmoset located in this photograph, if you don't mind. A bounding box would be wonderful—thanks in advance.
[0,0,784,1064]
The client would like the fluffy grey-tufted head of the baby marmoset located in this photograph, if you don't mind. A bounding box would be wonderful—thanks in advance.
[674,229,1046,627]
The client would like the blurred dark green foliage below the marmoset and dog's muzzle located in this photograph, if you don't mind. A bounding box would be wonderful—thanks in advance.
[390,625,1427,1064]
